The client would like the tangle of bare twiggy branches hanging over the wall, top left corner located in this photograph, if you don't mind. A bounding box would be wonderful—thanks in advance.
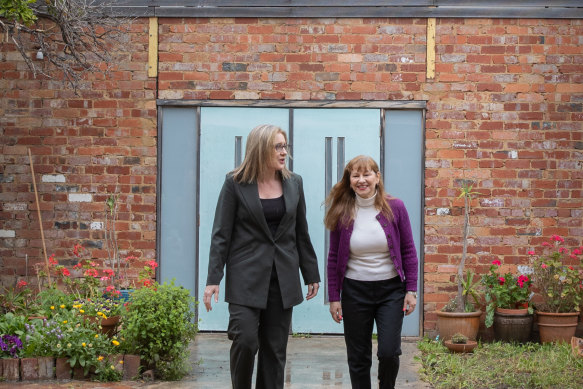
[0,0,130,92]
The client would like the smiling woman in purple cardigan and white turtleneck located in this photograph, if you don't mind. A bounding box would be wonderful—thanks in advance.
[324,155,417,389]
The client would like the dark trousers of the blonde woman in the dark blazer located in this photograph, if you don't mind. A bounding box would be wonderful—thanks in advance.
[228,269,293,389]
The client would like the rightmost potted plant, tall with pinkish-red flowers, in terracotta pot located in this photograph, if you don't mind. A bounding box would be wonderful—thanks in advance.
[528,235,583,343]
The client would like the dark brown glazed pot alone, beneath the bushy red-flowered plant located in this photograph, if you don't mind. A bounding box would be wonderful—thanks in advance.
[494,308,533,343]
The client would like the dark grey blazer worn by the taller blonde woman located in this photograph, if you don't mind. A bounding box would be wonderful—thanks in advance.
[207,173,320,309]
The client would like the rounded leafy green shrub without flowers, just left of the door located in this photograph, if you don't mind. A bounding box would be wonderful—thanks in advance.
[120,281,198,380]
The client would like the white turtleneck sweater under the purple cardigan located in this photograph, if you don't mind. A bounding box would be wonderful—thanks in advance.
[346,193,398,281]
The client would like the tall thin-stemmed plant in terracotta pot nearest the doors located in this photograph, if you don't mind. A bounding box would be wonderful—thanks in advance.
[437,181,482,340]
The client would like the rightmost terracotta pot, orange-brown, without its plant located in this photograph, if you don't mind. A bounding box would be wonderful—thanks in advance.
[536,311,579,343]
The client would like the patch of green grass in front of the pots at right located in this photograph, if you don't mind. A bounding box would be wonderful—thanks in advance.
[418,338,583,389]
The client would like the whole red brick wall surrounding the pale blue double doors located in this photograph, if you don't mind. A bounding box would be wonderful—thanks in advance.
[0,18,583,333]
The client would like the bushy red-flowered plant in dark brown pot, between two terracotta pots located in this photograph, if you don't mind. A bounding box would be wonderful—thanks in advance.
[481,260,533,342]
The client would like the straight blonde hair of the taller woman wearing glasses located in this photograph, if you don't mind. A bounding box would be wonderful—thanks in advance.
[232,124,291,184]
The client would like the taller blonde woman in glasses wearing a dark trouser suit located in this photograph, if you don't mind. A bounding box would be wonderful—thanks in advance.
[203,125,320,389]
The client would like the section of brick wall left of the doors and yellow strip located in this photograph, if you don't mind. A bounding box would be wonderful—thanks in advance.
[0,20,157,286]
